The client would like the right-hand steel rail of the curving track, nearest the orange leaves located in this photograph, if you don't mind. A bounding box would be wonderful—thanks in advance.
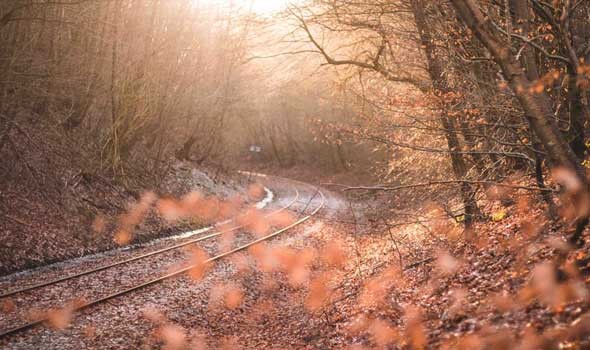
[0,181,326,339]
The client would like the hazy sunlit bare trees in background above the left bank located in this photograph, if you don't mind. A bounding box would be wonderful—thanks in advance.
[0,0,380,183]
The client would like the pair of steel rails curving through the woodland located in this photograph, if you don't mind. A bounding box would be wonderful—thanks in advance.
[0,176,326,339]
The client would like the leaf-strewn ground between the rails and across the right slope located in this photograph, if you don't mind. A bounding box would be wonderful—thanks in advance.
[0,164,590,349]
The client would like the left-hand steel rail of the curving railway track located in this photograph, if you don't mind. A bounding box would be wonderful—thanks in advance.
[0,189,299,298]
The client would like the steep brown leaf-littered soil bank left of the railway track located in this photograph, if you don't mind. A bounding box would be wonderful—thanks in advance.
[0,119,246,274]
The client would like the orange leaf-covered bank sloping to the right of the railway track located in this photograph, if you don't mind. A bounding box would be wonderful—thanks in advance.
[182,173,590,350]
